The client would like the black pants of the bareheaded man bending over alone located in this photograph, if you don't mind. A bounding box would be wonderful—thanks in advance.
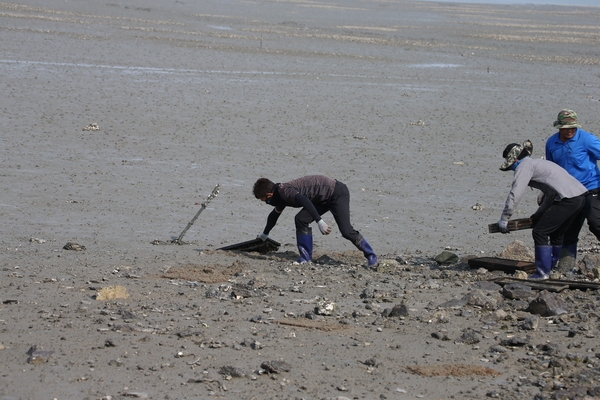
[294,181,362,244]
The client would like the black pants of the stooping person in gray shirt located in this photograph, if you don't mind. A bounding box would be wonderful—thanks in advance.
[532,194,586,246]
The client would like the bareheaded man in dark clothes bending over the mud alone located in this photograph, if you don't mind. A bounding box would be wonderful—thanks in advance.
[252,175,378,268]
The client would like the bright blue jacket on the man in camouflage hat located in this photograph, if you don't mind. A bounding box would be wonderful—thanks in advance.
[546,128,600,190]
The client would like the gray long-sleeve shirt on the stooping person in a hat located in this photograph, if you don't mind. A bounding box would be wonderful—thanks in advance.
[501,157,587,221]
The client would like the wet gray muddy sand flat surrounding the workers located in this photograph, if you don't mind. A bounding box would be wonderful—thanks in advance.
[0,0,600,400]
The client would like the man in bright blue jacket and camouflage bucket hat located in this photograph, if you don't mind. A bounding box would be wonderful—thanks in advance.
[546,109,600,261]
